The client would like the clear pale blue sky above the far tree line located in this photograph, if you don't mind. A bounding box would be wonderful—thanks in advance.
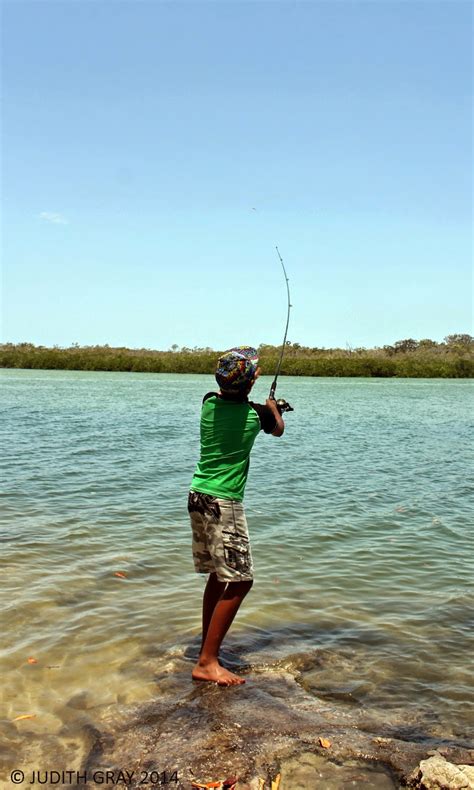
[2,0,473,349]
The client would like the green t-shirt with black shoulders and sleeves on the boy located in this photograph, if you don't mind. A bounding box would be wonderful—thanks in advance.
[191,392,276,501]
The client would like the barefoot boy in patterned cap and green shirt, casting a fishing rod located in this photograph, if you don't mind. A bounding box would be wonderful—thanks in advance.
[188,346,285,686]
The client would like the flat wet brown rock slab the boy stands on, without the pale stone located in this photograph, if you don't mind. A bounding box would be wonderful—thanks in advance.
[83,659,469,790]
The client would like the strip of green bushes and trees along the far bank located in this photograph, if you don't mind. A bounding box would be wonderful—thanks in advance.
[0,334,474,378]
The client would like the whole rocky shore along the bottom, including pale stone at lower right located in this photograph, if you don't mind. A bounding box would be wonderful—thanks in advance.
[3,651,474,790]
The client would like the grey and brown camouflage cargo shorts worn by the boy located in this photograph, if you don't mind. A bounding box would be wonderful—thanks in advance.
[188,491,253,582]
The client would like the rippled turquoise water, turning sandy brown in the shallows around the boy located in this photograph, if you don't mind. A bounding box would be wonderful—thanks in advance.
[0,370,474,772]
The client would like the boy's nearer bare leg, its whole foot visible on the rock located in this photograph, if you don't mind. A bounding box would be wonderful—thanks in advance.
[192,578,253,686]
